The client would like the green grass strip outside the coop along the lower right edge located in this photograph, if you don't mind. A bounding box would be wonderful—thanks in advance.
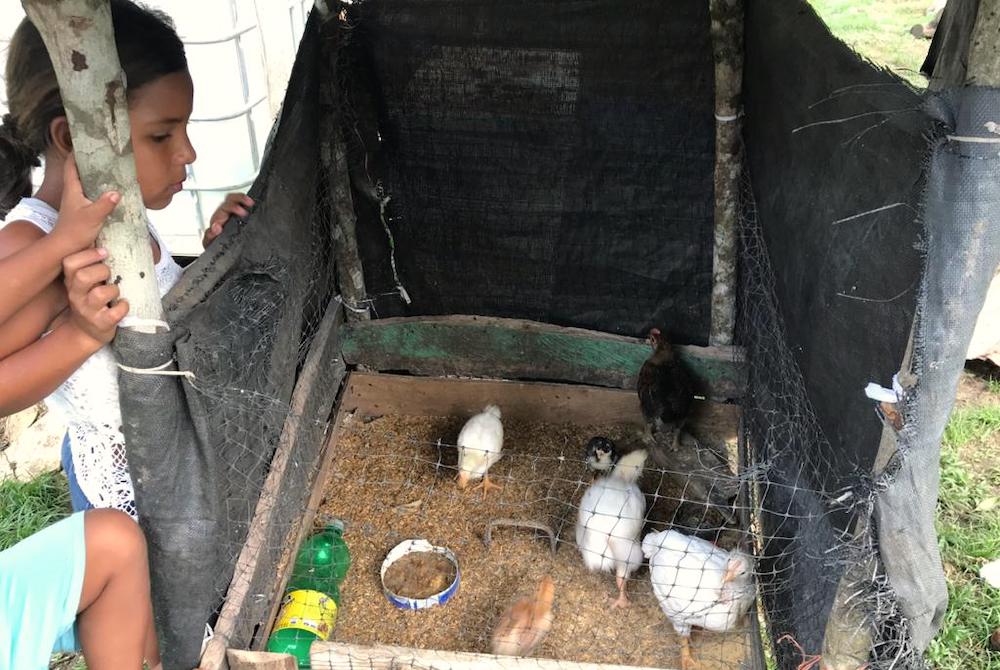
[927,402,1000,670]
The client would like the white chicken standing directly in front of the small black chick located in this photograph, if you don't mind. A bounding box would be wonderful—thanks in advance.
[576,449,647,608]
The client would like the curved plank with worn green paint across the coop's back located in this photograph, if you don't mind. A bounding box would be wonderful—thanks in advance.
[343,316,746,400]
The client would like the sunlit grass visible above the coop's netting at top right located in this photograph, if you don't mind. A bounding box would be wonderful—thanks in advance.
[810,0,931,87]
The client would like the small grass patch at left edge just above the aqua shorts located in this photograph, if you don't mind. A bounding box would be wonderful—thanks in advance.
[0,472,70,551]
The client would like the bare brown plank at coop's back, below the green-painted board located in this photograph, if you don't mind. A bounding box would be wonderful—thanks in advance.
[340,372,740,442]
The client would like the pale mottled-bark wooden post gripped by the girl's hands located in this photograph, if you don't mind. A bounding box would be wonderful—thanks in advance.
[21,0,165,333]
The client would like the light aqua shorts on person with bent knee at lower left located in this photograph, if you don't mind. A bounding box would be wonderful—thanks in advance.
[0,512,87,670]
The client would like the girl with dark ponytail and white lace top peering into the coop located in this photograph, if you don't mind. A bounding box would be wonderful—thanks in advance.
[0,0,252,517]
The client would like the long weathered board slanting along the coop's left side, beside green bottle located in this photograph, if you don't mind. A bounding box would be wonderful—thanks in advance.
[199,301,345,670]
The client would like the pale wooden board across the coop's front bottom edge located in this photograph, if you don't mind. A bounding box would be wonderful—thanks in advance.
[310,642,676,670]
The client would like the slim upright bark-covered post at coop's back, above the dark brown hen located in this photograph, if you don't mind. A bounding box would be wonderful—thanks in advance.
[709,0,743,345]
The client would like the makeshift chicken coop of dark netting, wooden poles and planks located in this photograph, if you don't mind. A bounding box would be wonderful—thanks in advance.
[68,0,1000,670]
